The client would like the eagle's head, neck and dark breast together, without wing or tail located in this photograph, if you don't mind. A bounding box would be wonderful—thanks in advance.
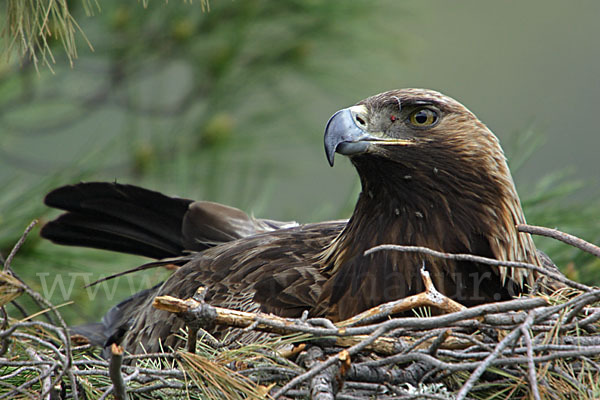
[322,89,540,316]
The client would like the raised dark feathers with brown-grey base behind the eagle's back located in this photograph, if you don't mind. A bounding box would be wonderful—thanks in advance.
[41,182,297,259]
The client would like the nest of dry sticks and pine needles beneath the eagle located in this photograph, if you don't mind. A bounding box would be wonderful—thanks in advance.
[0,220,600,399]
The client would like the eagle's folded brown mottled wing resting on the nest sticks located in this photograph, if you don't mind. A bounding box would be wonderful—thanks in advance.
[124,221,345,352]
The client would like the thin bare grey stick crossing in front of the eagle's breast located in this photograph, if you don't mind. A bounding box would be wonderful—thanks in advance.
[364,244,592,292]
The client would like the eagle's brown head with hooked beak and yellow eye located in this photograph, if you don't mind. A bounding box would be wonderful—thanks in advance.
[324,89,513,189]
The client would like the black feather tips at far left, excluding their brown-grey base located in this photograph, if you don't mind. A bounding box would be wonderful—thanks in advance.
[41,182,192,258]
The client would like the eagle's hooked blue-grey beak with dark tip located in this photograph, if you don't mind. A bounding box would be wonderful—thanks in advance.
[324,106,381,167]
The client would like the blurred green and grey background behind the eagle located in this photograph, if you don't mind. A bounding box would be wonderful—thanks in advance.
[0,0,600,323]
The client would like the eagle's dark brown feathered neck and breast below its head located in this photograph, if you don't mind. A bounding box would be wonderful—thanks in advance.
[321,154,540,319]
